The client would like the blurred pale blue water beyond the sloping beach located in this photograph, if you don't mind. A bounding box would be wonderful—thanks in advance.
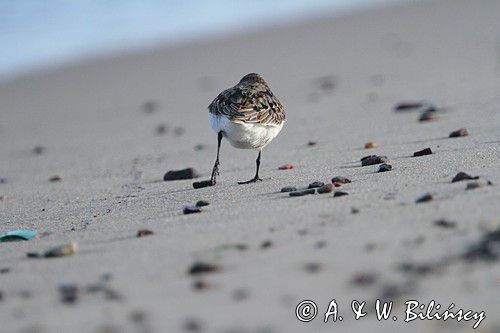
[0,0,402,79]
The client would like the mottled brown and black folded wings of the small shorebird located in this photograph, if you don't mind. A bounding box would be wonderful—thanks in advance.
[208,86,286,126]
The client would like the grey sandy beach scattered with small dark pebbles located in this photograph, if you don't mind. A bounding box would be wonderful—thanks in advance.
[0,0,500,333]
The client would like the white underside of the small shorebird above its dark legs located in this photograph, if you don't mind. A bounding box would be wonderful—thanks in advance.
[210,113,283,149]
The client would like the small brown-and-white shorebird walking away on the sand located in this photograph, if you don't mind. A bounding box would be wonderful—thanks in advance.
[208,73,286,186]
